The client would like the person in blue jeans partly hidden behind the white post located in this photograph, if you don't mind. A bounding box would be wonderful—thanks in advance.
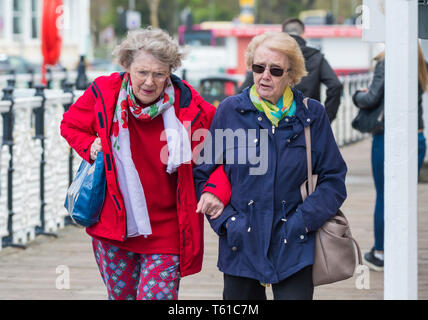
[352,46,428,271]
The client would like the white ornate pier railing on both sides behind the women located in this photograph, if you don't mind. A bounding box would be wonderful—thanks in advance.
[0,70,371,250]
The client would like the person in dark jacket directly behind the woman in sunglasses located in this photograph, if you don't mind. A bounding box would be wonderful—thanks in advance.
[240,18,343,123]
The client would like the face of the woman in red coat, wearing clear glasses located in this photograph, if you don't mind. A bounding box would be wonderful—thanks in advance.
[126,50,170,104]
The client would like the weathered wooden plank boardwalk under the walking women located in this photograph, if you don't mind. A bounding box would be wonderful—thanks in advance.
[0,139,428,300]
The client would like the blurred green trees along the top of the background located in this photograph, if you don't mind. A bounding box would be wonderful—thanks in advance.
[90,0,362,52]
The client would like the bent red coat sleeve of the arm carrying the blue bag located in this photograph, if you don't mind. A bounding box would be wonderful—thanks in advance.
[60,87,97,162]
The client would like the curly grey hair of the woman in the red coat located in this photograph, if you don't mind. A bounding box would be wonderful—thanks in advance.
[113,27,184,71]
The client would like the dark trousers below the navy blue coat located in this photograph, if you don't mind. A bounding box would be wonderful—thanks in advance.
[223,266,314,300]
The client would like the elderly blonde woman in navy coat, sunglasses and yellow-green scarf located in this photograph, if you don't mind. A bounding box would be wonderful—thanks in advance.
[194,32,347,299]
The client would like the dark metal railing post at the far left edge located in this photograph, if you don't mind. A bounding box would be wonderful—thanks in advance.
[2,87,25,249]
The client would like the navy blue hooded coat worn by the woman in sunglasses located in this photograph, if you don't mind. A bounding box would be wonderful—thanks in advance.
[193,89,347,283]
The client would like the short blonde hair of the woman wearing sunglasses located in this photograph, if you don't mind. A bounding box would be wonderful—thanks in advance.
[245,32,308,86]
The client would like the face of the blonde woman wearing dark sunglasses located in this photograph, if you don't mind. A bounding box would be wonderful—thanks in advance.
[253,44,290,104]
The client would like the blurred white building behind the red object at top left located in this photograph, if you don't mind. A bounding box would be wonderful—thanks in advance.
[0,0,92,69]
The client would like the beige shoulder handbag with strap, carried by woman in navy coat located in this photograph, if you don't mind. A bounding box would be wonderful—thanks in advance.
[300,99,362,286]
